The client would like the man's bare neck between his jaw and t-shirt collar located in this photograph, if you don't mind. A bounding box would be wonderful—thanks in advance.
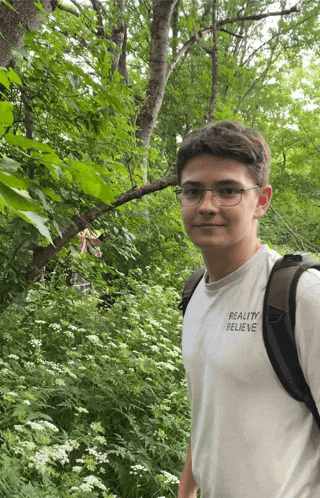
[202,238,262,283]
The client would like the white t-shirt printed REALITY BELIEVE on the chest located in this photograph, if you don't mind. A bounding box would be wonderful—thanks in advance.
[182,245,320,498]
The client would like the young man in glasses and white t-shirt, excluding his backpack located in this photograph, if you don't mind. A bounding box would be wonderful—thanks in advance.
[177,121,320,498]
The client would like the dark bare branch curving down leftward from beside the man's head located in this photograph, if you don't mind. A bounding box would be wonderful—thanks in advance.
[26,175,178,282]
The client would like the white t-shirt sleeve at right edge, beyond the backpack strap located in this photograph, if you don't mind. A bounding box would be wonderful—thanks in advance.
[295,269,320,412]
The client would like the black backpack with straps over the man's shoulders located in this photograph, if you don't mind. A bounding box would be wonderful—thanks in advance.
[179,253,320,429]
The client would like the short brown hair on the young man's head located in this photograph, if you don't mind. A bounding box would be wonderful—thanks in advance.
[176,121,270,186]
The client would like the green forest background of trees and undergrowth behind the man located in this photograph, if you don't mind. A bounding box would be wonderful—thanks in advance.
[0,0,320,498]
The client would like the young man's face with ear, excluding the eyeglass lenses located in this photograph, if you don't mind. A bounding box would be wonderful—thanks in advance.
[181,154,272,249]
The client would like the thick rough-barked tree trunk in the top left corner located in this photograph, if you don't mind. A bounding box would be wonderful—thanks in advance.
[0,0,58,67]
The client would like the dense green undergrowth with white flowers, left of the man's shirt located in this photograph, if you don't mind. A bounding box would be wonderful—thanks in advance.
[0,275,189,498]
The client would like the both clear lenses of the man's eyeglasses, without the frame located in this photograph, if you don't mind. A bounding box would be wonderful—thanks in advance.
[178,186,241,207]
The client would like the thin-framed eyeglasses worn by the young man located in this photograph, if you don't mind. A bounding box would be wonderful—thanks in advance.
[175,185,261,207]
